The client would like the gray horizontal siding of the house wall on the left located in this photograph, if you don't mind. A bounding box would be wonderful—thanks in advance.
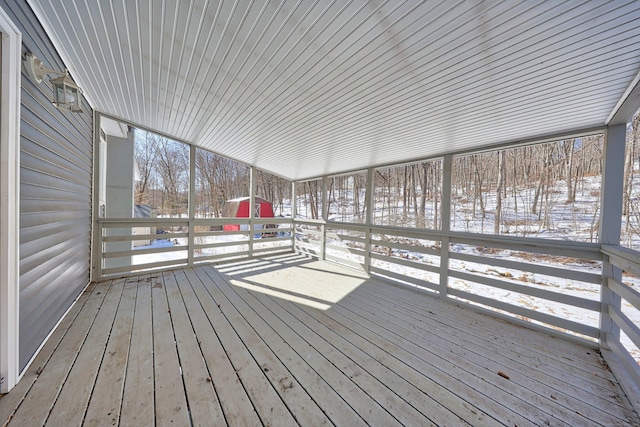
[3,1,93,369]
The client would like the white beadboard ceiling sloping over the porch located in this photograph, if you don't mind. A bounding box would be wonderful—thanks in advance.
[28,0,640,180]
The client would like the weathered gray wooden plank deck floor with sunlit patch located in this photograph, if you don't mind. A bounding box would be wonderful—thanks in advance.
[0,255,640,427]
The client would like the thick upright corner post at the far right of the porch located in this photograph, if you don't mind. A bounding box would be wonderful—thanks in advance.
[600,124,627,349]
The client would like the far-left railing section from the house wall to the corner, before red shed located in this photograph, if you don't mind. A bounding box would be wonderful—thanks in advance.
[94,218,294,279]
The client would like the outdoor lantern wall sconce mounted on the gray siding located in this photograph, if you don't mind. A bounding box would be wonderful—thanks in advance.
[24,53,82,113]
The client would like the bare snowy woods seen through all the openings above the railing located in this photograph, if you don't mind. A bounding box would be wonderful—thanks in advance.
[130,115,640,247]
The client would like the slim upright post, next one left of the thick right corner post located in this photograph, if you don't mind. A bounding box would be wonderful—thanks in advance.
[438,154,453,299]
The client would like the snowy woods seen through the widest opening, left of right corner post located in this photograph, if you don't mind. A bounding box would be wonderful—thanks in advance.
[452,135,604,240]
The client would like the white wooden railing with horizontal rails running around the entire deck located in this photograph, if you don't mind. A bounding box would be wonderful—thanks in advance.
[94,218,640,394]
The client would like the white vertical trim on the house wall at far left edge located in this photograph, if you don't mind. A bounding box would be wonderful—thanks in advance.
[0,7,22,393]
